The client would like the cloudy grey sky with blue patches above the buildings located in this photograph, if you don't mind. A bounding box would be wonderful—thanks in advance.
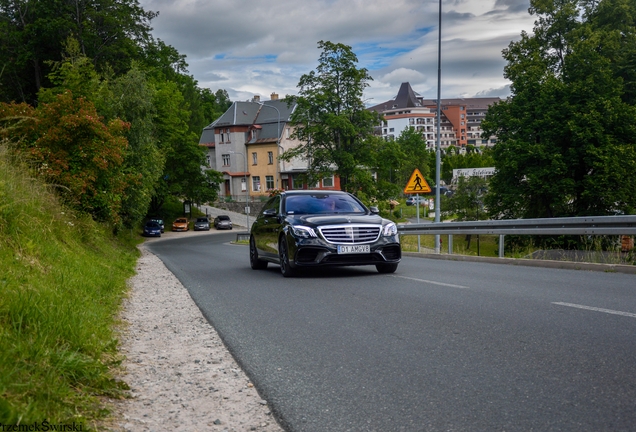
[140,0,534,105]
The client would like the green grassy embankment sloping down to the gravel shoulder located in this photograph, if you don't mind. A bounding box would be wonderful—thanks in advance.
[0,148,140,430]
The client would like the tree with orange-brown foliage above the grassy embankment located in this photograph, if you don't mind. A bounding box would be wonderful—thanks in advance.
[0,91,129,226]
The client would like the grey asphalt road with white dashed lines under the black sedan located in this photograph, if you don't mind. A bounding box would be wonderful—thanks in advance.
[149,232,636,432]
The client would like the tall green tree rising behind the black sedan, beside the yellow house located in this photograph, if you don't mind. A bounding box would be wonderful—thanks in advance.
[283,41,380,191]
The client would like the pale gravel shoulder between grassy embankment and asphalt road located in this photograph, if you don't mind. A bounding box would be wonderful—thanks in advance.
[104,231,283,432]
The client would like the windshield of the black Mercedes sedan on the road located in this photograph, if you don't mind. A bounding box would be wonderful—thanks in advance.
[285,194,366,214]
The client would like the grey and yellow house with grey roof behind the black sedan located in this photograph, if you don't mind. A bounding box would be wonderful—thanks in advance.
[199,93,340,200]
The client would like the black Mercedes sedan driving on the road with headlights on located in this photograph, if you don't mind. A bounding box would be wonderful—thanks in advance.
[250,190,402,277]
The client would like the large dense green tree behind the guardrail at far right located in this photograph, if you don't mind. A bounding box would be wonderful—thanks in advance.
[483,0,636,218]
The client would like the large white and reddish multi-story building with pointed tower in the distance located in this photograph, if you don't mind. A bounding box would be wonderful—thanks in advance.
[369,82,501,149]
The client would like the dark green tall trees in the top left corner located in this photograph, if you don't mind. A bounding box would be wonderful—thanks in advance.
[0,0,157,105]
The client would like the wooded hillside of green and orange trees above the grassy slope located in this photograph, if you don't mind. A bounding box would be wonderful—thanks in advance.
[0,0,230,231]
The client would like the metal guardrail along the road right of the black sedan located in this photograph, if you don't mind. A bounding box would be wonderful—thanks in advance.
[398,215,636,258]
